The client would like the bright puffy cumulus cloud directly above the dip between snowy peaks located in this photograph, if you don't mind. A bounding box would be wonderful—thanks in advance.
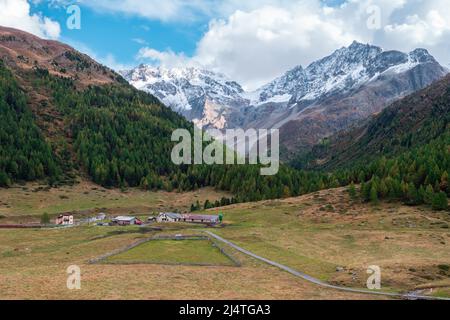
[195,1,360,88]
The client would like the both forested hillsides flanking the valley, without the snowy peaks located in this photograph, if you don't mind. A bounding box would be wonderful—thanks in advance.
[0,29,450,208]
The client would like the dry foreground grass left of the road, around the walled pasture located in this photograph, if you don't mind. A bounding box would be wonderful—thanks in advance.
[0,227,372,300]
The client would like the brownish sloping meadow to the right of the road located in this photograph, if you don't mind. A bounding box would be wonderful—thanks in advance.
[207,188,450,296]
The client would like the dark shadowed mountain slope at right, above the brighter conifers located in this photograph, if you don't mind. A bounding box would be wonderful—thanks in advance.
[292,75,450,171]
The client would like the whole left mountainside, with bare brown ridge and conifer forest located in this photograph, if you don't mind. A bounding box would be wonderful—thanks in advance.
[0,26,325,202]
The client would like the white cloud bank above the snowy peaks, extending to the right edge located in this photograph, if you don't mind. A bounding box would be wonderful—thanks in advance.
[136,0,450,89]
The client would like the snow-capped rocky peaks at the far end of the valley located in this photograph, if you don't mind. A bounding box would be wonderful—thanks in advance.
[122,41,448,157]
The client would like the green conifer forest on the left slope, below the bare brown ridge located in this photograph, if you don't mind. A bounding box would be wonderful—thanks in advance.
[2,61,338,201]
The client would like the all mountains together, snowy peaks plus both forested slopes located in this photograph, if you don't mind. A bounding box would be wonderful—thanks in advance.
[0,27,450,210]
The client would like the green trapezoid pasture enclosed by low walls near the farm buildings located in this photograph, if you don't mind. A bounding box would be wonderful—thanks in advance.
[105,240,233,266]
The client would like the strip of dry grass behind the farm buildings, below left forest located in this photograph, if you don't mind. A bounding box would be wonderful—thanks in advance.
[0,181,231,223]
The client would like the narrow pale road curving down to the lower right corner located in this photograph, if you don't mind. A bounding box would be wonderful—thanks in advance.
[205,231,450,300]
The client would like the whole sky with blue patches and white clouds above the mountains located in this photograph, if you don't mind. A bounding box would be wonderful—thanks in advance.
[0,0,450,89]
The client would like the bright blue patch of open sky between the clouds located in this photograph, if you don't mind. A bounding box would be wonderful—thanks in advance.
[32,1,208,66]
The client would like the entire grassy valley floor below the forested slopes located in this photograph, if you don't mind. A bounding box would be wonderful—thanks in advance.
[0,186,450,300]
